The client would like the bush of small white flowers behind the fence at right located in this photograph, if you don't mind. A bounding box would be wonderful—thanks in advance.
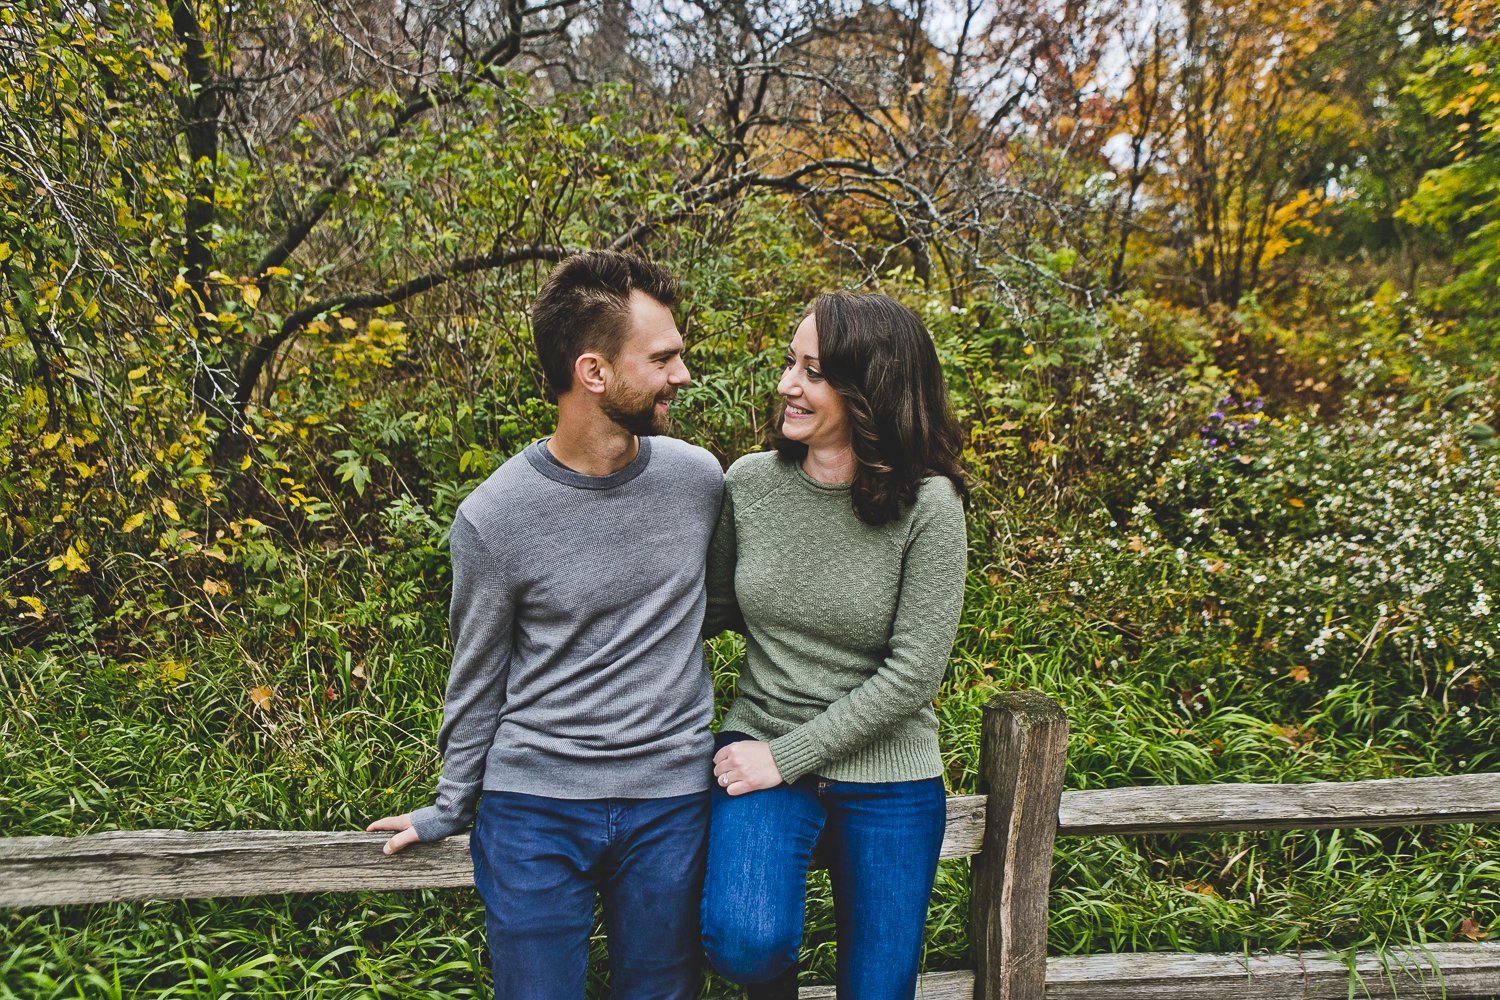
[1056,335,1500,680]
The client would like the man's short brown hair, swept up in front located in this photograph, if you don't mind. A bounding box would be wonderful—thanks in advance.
[531,250,678,399]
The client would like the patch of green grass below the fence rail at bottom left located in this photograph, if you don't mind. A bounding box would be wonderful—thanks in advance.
[0,892,488,999]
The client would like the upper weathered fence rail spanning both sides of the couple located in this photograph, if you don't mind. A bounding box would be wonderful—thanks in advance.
[0,774,1500,907]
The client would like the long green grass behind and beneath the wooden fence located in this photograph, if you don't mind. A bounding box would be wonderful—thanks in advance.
[0,563,1500,1000]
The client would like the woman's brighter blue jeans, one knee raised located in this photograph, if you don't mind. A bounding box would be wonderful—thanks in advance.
[704,735,948,1000]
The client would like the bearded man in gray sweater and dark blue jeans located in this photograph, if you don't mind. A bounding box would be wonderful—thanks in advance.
[368,252,723,1000]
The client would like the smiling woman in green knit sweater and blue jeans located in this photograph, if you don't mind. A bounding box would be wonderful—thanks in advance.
[704,292,966,1000]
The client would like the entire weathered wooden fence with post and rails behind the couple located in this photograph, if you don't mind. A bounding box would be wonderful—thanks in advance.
[0,691,1500,1000]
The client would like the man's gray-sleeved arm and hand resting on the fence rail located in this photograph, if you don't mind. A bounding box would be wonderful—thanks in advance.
[366,511,515,855]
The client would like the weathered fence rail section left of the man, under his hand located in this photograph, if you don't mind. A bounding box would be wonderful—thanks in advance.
[0,831,474,907]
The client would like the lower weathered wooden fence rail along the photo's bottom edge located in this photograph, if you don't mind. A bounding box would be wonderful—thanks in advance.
[798,945,1500,1000]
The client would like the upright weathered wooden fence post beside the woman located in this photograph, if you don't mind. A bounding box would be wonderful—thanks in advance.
[969,691,1068,1000]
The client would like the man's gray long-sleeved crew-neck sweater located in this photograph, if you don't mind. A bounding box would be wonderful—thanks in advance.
[413,438,723,841]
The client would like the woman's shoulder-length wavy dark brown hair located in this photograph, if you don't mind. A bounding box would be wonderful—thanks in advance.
[767,291,969,525]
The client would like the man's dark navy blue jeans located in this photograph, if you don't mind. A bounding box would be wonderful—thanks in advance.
[470,792,708,1000]
